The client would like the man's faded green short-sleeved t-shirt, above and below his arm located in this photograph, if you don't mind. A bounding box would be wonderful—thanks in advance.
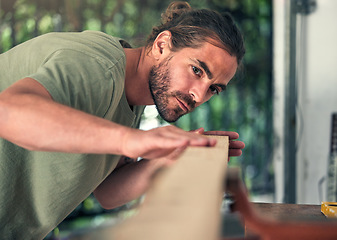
[0,31,144,239]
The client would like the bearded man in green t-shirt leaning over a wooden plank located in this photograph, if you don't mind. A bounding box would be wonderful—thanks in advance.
[0,2,244,239]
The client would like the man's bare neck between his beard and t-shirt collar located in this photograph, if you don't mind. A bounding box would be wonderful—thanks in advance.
[124,47,153,106]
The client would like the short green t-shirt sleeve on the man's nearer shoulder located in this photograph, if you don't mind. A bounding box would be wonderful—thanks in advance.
[29,50,121,116]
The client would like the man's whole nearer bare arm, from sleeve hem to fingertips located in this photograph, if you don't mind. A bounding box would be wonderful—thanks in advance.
[0,78,215,158]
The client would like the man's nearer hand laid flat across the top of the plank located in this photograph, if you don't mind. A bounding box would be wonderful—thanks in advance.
[121,125,216,159]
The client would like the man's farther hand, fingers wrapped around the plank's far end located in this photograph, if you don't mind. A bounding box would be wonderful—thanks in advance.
[193,128,245,157]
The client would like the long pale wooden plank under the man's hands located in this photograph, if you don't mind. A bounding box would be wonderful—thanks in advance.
[111,136,229,240]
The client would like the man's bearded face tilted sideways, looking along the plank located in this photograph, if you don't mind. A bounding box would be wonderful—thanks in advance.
[149,43,237,122]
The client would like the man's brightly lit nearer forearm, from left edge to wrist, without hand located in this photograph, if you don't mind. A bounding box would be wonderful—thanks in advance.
[0,78,131,154]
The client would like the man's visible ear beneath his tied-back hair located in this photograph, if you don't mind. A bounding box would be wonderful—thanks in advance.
[151,30,172,61]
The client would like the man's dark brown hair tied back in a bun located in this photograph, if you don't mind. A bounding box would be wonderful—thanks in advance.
[147,2,245,64]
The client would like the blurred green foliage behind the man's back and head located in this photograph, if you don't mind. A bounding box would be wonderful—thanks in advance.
[0,0,274,214]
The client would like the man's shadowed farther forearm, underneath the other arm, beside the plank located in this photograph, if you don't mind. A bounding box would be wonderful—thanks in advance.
[94,158,165,209]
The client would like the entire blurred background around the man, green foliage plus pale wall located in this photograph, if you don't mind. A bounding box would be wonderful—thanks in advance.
[0,0,337,238]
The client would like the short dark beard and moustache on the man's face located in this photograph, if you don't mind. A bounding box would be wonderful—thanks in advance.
[149,57,195,122]
